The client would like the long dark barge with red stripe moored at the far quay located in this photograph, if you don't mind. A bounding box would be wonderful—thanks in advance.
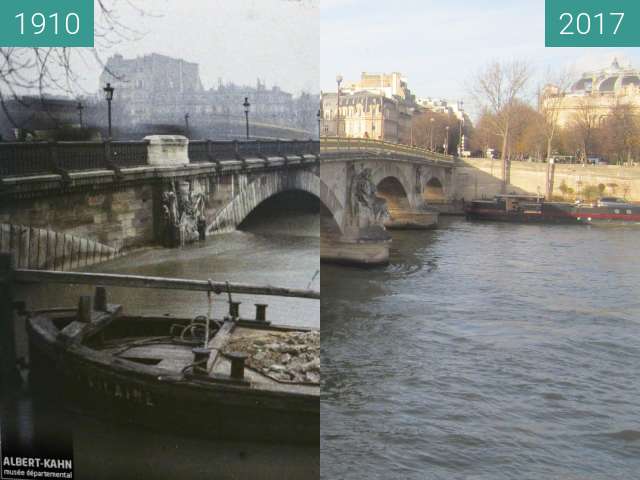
[465,195,640,226]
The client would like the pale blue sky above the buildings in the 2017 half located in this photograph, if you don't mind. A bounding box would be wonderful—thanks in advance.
[320,0,640,100]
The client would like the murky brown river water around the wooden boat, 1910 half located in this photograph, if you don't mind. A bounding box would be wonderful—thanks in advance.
[5,196,320,480]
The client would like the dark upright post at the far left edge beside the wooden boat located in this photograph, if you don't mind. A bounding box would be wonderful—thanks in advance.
[0,253,20,392]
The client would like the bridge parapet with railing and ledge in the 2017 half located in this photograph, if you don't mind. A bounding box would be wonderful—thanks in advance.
[320,137,456,166]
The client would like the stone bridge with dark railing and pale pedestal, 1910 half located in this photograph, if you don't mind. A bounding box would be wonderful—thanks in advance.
[0,136,320,251]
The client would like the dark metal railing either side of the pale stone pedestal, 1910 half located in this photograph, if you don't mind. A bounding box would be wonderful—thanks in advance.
[0,140,320,178]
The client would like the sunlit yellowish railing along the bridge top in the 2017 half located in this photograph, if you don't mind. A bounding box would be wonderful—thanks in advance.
[320,137,456,163]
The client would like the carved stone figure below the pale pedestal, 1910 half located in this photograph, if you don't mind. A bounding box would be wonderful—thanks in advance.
[162,182,205,247]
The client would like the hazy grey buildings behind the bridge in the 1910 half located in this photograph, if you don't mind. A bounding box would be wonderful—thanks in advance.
[100,54,319,136]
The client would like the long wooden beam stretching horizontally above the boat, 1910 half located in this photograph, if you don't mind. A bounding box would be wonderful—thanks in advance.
[15,269,320,300]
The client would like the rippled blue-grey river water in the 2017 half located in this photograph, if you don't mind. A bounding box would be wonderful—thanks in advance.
[321,219,640,480]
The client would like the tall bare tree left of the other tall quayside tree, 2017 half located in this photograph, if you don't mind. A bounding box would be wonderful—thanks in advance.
[470,60,531,189]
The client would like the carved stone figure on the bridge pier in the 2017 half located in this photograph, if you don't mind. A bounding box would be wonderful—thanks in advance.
[350,168,389,226]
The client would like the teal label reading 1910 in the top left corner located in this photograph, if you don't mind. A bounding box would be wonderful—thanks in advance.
[0,0,94,47]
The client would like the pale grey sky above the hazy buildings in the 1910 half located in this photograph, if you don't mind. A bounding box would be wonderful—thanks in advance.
[77,0,320,94]
